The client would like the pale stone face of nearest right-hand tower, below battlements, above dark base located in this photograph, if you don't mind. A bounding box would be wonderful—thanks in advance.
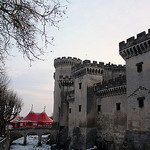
[126,40,150,131]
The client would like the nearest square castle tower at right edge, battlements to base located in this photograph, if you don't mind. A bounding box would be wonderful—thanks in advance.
[119,29,150,150]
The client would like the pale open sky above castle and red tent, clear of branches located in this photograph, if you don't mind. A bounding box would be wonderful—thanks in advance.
[7,0,150,116]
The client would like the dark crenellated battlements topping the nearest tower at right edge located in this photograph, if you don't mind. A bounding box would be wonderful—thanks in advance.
[119,29,150,59]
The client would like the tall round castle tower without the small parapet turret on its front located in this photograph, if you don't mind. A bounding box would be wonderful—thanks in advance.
[53,57,82,123]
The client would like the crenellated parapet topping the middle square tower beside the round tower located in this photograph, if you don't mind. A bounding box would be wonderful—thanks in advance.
[71,60,104,78]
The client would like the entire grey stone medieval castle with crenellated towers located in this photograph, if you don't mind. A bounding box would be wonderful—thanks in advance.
[53,29,150,150]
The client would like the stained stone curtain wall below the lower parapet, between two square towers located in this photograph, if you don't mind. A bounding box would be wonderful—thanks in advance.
[97,94,127,143]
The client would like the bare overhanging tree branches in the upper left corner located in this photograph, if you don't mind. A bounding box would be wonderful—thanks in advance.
[0,0,67,65]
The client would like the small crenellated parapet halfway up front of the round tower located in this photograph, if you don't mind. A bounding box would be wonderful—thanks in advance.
[59,75,74,87]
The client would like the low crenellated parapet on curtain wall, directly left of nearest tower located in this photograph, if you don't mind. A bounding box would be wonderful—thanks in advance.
[94,76,126,97]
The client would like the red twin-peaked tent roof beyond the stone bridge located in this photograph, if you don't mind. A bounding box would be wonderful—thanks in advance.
[21,111,53,122]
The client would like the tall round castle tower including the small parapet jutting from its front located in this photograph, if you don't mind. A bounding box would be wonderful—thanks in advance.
[53,57,81,126]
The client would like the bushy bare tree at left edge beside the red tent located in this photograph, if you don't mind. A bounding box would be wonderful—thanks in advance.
[0,75,23,136]
